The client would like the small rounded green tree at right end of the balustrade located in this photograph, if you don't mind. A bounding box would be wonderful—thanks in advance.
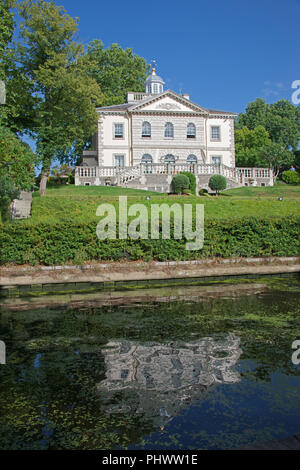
[260,142,293,180]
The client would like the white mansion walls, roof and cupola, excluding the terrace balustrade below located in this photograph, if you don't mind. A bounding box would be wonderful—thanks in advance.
[83,69,236,167]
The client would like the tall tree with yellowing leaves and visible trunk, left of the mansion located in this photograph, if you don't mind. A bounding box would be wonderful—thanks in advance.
[17,0,103,195]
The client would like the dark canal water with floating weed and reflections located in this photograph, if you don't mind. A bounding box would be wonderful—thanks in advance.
[0,276,300,450]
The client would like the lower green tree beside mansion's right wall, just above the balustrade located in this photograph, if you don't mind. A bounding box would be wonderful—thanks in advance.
[235,125,271,167]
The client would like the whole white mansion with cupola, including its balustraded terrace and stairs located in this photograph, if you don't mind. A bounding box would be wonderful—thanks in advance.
[75,68,273,192]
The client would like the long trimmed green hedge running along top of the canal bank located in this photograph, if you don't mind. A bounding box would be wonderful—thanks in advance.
[0,217,300,265]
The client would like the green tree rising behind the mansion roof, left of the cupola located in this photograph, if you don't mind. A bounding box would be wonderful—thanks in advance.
[86,39,149,106]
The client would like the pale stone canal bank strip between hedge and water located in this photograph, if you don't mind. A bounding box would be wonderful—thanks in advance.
[0,257,300,291]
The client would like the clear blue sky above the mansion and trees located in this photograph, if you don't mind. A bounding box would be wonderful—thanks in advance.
[55,0,300,112]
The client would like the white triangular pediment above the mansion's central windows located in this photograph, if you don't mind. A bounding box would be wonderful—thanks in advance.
[130,91,207,114]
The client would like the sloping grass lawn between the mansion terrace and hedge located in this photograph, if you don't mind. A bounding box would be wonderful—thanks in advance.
[14,183,300,224]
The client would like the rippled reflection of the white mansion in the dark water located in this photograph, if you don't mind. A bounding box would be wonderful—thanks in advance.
[98,334,242,425]
